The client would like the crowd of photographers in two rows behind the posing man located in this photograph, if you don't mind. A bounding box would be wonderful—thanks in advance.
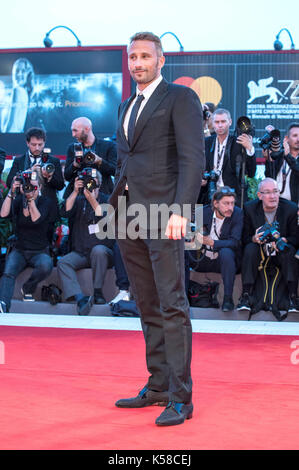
[0,107,299,315]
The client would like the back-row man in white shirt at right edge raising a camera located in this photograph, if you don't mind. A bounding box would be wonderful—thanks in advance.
[261,123,299,204]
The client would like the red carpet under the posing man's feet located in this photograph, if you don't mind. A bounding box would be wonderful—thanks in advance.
[0,326,299,450]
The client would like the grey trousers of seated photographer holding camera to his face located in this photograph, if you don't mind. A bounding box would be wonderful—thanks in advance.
[57,245,113,299]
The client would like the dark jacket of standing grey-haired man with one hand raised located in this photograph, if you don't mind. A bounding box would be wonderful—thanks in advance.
[199,134,256,204]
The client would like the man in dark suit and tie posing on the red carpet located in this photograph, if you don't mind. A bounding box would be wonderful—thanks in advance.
[110,33,205,426]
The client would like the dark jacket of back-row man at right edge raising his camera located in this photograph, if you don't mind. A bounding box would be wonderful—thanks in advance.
[265,152,299,204]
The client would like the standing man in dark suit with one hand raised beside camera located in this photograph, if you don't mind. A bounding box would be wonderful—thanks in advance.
[198,108,256,206]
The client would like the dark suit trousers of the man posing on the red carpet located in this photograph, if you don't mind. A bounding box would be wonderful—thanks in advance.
[118,233,192,403]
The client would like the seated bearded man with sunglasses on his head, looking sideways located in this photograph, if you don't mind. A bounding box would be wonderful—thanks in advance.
[185,186,243,312]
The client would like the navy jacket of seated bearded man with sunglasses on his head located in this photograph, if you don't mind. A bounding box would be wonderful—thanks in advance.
[203,205,243,255]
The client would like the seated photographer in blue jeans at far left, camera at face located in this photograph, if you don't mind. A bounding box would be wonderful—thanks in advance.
[0,171,53,313]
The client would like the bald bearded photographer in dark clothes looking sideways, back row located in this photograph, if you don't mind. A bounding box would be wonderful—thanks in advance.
[64,117,117,199]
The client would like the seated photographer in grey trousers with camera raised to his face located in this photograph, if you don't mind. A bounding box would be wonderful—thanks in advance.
[57,168,114,315]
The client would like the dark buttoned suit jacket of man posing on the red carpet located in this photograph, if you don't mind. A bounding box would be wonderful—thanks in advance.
[110,79,205,222]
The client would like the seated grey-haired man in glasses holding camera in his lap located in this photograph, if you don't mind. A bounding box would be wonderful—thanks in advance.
[237,178,298,313]
